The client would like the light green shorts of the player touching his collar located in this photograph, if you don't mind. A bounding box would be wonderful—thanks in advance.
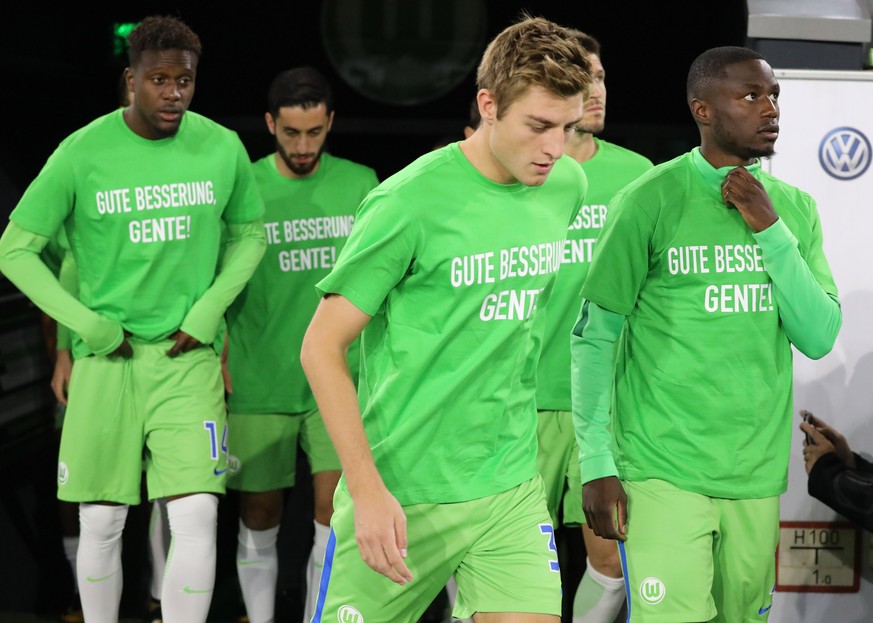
[619,480,779,623]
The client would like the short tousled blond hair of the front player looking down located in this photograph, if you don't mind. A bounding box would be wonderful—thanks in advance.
[476,16,591,118]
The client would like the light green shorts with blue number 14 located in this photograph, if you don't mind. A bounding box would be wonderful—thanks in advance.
[58,340,227,504]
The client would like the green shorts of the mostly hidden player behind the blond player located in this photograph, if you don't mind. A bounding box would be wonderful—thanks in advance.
[537,411,585,526]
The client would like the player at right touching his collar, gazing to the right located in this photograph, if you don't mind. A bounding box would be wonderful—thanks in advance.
[571,46,842,623]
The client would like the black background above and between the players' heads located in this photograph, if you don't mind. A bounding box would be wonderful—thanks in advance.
[0,0,747,196]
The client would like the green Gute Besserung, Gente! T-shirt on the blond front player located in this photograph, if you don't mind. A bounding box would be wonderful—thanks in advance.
[318,144,587,505]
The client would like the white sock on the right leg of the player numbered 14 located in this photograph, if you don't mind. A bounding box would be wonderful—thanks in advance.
[163,493,218,623]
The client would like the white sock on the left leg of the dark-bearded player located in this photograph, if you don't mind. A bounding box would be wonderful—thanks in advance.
[236,519,279,623]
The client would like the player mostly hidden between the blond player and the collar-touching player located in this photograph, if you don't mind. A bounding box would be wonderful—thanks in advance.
[537,30,653,623]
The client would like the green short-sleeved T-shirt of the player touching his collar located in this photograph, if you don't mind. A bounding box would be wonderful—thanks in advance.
[582,149,837,498]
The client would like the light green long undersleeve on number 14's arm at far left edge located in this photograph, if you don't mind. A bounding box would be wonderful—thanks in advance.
[0,223,124,355]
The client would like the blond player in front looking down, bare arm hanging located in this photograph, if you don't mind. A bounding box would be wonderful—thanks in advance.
[301,18,590,623]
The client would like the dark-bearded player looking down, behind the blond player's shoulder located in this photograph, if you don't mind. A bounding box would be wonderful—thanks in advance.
[227,67,378,623]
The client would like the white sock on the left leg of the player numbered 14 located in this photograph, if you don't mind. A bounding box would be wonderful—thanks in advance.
[76,504,127,623]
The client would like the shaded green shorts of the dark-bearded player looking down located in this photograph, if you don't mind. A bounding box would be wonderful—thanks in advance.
[227,409,341,493]
